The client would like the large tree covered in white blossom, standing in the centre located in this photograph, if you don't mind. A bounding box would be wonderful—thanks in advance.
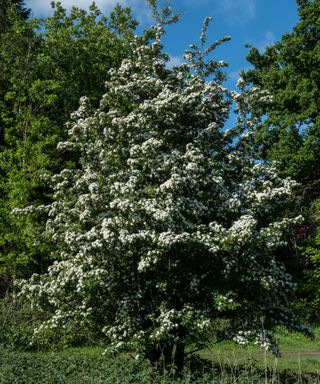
[20,20,310,368]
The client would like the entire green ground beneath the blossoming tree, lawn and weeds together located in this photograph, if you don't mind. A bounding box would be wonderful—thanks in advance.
[0,330,320,384]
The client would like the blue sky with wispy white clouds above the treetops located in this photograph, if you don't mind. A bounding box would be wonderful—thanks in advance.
[25,0,298,88]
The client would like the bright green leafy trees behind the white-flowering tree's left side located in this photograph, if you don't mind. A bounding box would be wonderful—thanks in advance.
[0,3,137,276]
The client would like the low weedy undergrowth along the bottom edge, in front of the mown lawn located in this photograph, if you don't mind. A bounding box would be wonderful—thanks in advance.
[0,348,320,384]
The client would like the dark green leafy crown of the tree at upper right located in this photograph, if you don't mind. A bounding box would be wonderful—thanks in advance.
[243,0,320,205]
